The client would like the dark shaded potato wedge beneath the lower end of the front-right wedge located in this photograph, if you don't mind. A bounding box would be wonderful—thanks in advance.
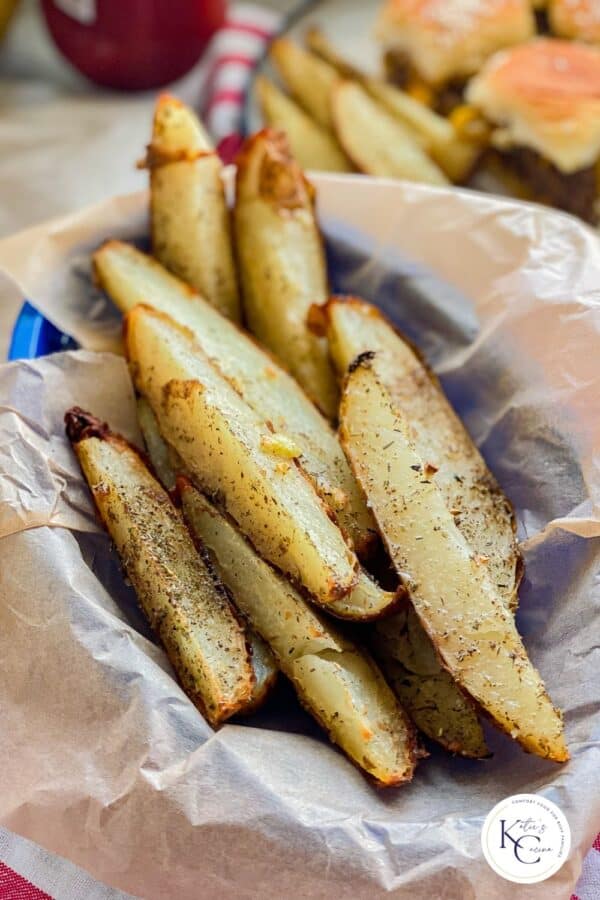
[369,604,490,759]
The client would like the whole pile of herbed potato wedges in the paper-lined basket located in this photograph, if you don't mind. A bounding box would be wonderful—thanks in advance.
[65,93,568,786]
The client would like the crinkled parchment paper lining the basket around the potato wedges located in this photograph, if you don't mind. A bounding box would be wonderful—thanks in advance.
[0,176,600,900]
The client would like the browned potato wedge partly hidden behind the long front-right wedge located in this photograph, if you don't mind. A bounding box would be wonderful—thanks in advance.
[318,297,522,611]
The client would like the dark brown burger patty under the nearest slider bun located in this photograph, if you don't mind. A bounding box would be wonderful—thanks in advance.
[502,147,598,225]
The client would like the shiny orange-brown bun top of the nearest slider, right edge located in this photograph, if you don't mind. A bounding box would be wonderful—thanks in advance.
[467,38,600,173]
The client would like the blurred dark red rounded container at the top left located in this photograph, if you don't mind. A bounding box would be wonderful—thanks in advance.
[42,0,225,91]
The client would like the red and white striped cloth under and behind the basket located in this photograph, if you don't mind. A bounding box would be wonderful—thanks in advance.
[0,4,600,900]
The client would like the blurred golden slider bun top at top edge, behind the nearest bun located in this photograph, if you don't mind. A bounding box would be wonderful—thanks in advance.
[376,0,535,84]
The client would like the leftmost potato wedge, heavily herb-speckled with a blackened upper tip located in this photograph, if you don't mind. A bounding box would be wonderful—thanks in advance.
[65,407,255,726]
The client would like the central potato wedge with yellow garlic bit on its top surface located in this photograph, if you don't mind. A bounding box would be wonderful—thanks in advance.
[125,306,358,604]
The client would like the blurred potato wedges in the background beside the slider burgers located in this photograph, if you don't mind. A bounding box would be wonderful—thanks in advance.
[255,28,487,185]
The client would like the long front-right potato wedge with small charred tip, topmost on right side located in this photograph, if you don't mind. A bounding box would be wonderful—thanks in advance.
[340,353,569,762]
